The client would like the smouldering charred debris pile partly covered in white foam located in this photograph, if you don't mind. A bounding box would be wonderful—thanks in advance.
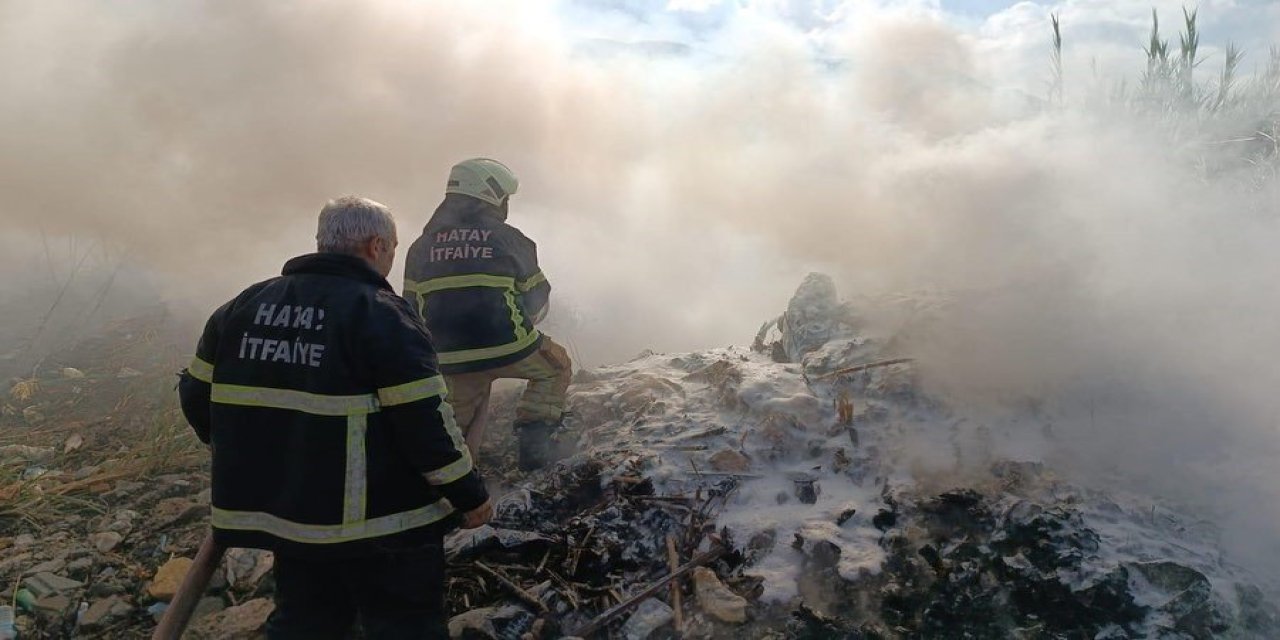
[442,275,1280,639]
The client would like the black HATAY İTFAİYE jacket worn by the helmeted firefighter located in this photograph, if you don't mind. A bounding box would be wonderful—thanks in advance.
[404,193,552,374]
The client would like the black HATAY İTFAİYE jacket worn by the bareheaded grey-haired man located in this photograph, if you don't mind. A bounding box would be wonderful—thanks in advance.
[179,253,488,557]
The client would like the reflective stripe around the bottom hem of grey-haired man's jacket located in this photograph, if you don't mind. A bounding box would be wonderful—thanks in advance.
[217,499,453,544]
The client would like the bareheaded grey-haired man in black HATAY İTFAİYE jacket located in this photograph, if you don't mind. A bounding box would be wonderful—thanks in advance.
[179,197,492,639]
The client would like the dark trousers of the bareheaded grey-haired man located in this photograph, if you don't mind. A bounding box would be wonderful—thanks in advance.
[266,544,449,640]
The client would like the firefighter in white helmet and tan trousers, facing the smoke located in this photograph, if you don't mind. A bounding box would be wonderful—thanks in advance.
[404,157,572,471]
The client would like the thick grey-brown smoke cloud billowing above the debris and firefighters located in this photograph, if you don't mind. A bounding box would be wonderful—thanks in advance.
[0,0,1280,576]
